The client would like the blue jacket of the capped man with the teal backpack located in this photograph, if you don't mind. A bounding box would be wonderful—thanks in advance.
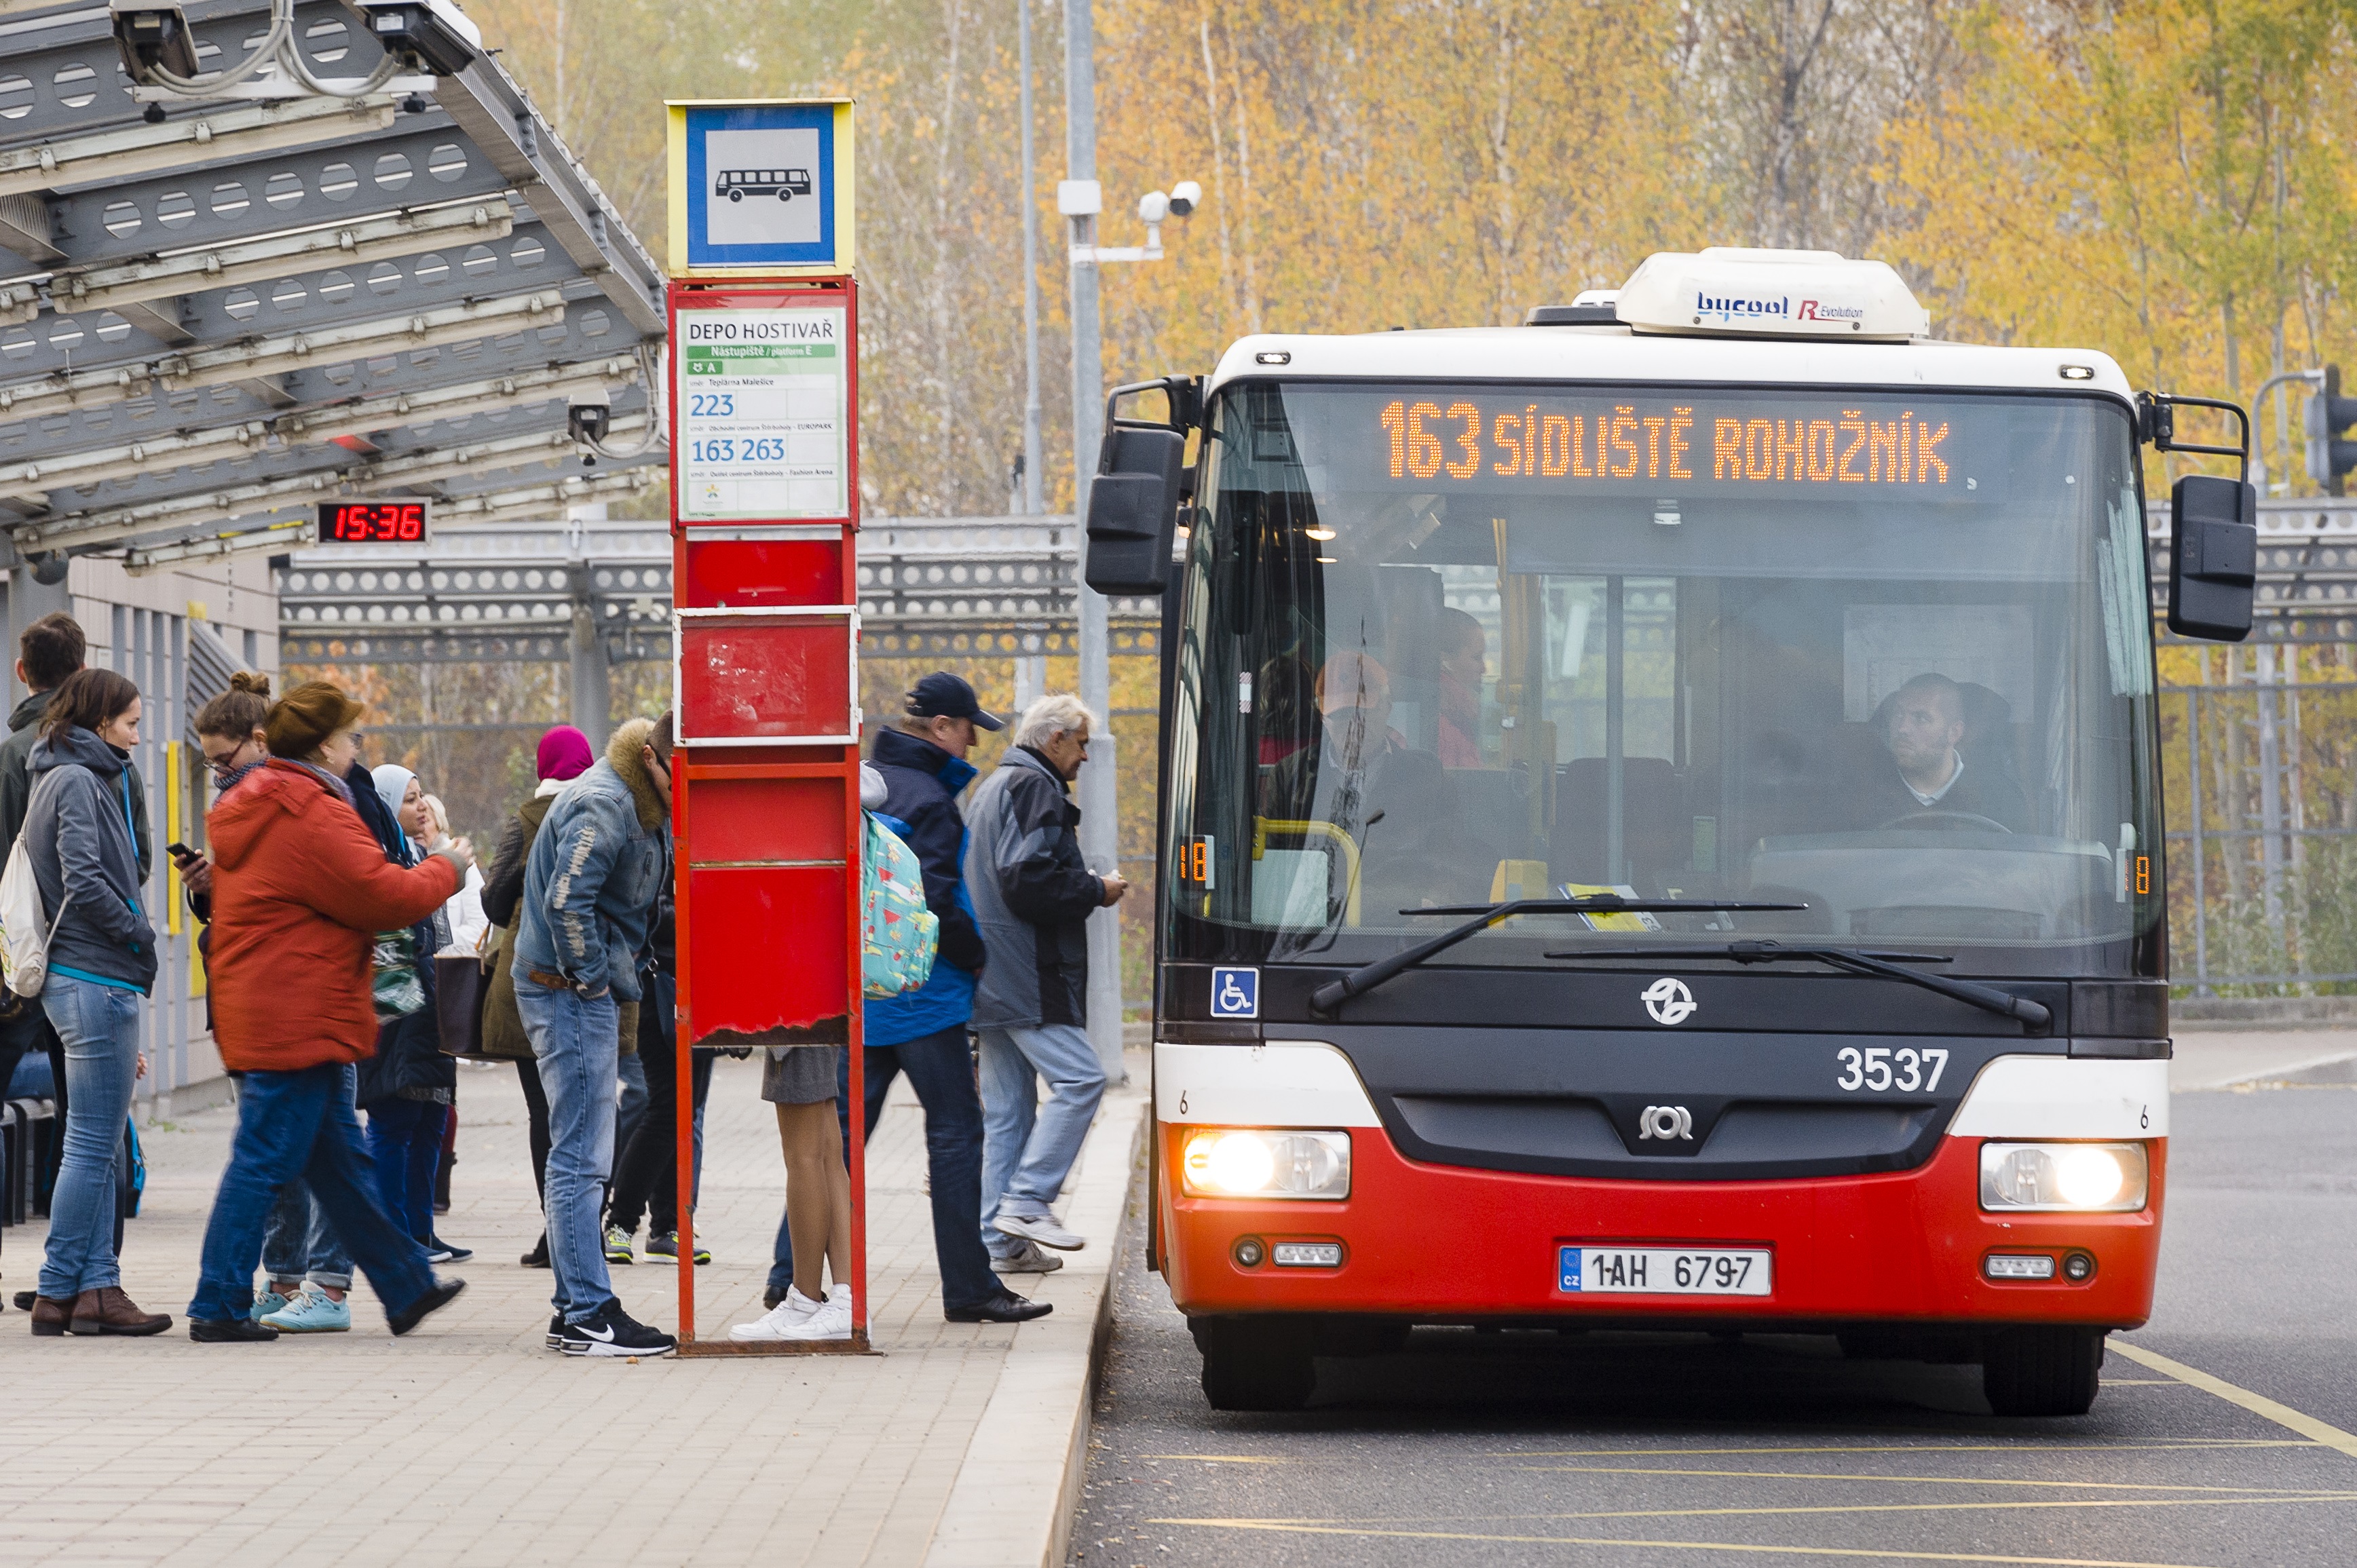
[865,729,983,1045]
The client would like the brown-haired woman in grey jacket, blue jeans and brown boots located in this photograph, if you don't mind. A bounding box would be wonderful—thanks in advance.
[24,670,172,1335]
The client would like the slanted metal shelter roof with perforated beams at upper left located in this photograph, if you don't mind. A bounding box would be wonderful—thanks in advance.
[0,0,664,571]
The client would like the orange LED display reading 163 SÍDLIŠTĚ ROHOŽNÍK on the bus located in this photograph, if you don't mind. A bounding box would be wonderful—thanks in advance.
[1304,387,2010,502]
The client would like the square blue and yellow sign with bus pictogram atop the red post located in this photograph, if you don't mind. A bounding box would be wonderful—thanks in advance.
[662,99,856,278]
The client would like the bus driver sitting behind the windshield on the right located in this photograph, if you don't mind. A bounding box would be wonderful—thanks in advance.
[1853,672,2029,833]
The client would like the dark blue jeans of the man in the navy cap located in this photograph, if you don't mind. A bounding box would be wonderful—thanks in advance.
[768,1023,1013,1311]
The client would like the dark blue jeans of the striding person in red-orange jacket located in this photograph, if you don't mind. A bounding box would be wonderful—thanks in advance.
[189,1061,434,1320]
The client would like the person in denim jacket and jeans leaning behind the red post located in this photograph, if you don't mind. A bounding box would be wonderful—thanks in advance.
[516,714,672,1356]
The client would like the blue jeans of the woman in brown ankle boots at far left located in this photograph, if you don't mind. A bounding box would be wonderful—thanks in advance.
[40,974,139,1301]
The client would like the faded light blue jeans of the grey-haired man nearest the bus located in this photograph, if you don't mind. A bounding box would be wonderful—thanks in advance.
[978,1023,1106,1257]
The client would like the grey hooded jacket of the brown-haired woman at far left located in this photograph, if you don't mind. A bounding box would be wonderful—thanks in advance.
[24,724,155,993]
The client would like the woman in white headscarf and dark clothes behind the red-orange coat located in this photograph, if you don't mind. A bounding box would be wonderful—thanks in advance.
[344,761,474,1264]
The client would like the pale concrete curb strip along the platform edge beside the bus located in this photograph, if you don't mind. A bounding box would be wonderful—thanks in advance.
[924,1092,1146,1568]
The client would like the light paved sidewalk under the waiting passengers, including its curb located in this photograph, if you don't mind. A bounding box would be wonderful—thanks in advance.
[0,1058,1146,1568]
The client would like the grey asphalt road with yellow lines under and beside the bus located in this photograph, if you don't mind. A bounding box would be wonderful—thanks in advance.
[1070,1087,2357,1568]
